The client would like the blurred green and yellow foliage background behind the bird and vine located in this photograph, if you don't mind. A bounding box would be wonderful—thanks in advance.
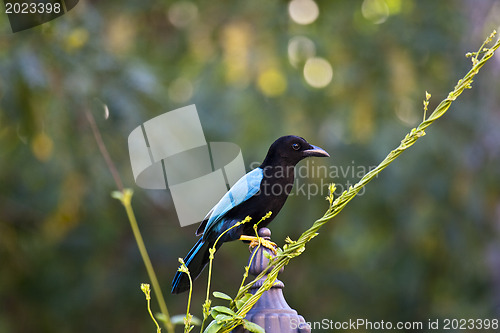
[0,0,500,333]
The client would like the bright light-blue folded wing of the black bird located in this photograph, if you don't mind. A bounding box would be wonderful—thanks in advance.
[198,168,264,232]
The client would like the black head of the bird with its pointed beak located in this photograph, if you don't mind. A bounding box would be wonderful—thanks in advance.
[262,135,330,166]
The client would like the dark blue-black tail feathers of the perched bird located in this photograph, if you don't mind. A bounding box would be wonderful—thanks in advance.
[172,237,214,294]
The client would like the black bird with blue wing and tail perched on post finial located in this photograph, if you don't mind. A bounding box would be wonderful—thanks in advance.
[171,135,330,294]
